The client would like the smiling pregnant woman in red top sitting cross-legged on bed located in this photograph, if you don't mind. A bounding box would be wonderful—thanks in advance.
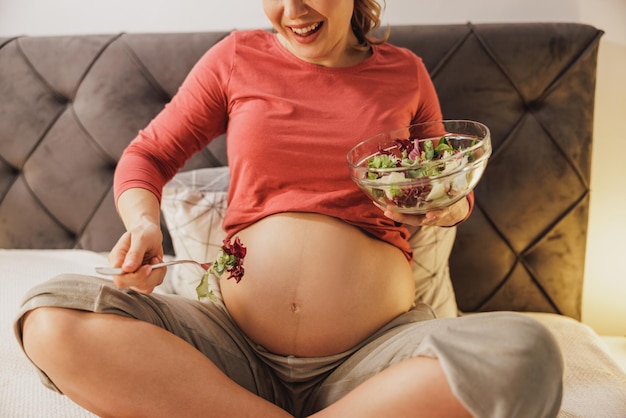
[16,0,562,418]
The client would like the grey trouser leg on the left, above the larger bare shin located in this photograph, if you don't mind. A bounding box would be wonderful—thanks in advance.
[15,274,279,402]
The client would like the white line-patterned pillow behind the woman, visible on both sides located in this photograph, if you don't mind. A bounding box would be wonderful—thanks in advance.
[161,167,457,317]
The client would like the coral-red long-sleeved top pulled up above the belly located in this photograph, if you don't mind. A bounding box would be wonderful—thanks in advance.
[115,30,471,259]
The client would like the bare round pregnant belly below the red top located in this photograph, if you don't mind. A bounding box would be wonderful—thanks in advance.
[221,213,414,357]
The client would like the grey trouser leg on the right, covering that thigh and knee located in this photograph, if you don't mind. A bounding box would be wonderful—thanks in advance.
[309,311,562,417]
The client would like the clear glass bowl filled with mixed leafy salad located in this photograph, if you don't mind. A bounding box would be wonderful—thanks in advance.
[347,120,491,214]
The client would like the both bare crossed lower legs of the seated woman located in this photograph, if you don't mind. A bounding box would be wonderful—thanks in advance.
[23,308,469,418]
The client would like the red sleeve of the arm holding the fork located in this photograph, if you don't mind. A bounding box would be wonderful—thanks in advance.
[114,34,236,202]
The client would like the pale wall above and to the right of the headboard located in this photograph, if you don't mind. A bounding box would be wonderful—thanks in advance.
[0,0,626,335]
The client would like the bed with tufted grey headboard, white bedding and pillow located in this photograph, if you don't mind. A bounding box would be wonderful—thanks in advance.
[0,23,626,418]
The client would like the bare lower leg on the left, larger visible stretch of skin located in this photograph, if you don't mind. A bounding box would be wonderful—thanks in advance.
[23,308,290,417]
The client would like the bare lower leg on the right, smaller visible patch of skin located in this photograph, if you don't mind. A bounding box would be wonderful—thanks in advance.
[313,357,471,418]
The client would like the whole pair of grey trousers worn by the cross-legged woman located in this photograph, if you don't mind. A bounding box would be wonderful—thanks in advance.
[15,274,563,418]
